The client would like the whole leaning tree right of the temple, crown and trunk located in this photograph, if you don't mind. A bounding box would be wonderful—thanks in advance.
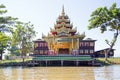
[88,3,120,61]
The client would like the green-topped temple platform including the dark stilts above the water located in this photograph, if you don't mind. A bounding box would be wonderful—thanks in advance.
[29,55,94,66]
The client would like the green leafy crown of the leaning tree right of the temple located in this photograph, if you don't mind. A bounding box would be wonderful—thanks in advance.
[88,3,120,33]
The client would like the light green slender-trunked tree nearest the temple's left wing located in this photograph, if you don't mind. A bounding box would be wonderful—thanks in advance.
[12,22,35,62]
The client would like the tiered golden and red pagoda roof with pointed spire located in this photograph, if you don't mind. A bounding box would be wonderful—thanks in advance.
[42,6,85,38]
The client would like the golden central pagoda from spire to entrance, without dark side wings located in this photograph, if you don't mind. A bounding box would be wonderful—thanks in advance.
[42,6,85,55]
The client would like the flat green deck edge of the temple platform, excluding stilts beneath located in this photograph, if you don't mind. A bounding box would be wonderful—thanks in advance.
[33,55,94,61]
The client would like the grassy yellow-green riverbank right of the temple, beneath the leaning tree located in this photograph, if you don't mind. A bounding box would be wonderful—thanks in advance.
[97,57,120,65]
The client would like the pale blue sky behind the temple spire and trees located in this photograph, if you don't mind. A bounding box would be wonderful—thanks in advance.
[0,0,120,57]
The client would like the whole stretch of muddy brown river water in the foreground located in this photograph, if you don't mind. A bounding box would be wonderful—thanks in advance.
[0,65,120,80]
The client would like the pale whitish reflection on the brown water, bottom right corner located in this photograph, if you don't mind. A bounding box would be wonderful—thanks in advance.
[94,65,120,80]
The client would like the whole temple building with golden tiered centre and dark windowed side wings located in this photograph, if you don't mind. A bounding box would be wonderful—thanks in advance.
[34,7,114,57]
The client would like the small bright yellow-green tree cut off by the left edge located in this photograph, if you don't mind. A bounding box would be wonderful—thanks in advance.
[0,32,10,60]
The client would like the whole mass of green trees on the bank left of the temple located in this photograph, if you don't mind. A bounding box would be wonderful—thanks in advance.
[0,4,36,59]
